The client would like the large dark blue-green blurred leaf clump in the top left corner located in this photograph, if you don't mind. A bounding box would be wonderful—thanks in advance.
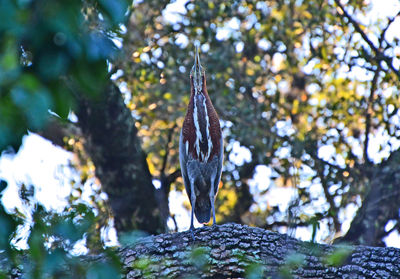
[0,0,129,150]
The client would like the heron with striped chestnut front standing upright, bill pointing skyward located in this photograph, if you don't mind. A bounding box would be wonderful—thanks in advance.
[179,46,223,230]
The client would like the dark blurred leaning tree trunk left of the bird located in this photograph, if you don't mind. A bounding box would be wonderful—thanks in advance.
[77,83,164,234]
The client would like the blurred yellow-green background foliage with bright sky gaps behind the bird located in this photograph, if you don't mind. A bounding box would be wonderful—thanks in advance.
[116,0,400,241]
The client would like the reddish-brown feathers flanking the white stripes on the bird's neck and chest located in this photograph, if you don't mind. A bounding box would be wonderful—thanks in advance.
[182,75,221,161]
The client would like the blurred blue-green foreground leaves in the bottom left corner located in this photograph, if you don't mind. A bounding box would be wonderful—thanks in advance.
[0,180,122,279]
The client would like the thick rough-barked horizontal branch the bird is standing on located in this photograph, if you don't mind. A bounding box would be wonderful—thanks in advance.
[120,224,400,279]
